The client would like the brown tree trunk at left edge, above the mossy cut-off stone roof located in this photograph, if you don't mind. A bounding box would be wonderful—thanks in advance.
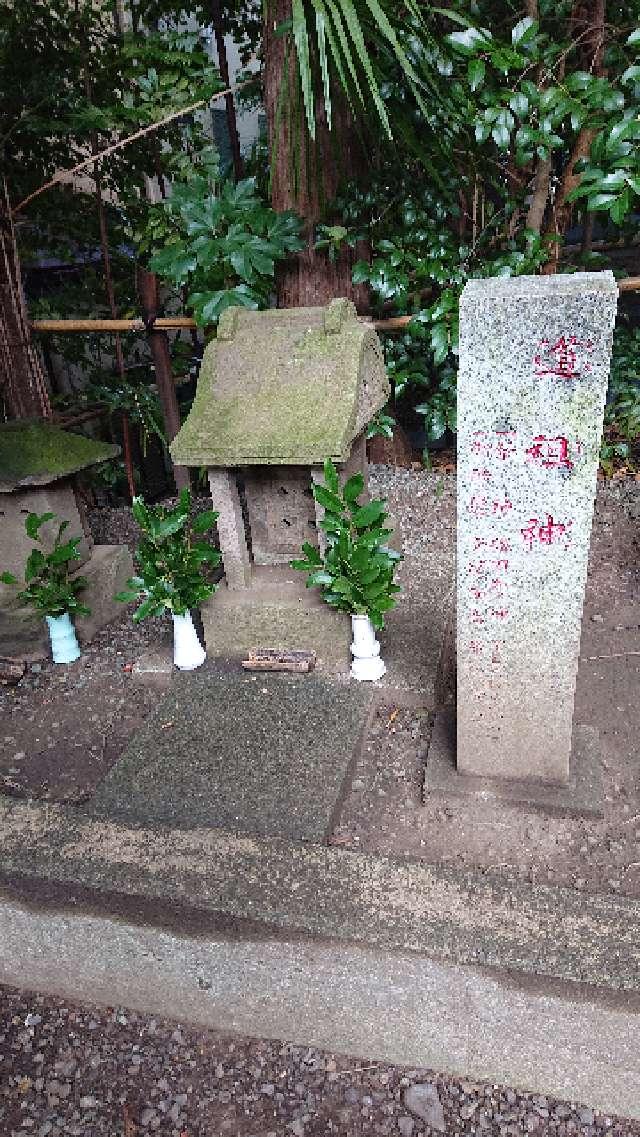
[0,186,51,418]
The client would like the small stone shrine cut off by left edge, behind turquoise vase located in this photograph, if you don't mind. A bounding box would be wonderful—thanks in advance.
[0,421,133,658]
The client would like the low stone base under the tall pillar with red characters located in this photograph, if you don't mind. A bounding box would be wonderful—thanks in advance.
[424,709,605,818]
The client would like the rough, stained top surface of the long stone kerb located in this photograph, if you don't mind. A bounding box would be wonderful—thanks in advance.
[0,798,640,993]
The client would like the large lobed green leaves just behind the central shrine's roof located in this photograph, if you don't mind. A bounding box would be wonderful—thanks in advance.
[150,177,302,325]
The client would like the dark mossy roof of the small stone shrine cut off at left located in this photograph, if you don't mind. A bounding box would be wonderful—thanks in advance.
[0,421,119,493]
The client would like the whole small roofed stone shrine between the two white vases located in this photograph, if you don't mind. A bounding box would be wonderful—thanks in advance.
[171,299,390,670]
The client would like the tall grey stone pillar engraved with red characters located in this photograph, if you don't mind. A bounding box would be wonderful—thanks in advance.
[457,272,617,785]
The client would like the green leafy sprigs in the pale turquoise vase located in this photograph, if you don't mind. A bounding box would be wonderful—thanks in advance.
[0,513,91,616]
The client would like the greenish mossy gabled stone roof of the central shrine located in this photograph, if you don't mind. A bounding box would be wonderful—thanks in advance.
[171,299,390,466]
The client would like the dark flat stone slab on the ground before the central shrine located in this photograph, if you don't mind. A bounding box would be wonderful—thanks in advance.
[88,664,372,841]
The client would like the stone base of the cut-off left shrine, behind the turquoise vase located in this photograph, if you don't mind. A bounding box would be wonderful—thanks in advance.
[0,545,133,662]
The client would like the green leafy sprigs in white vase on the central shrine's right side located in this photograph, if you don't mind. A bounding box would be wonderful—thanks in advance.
[291,459,401,628]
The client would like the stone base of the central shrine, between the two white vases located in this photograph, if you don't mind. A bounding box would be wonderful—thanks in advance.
[200,566,351,673]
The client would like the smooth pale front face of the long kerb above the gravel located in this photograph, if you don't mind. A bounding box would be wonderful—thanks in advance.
[5,899,640,1118]
